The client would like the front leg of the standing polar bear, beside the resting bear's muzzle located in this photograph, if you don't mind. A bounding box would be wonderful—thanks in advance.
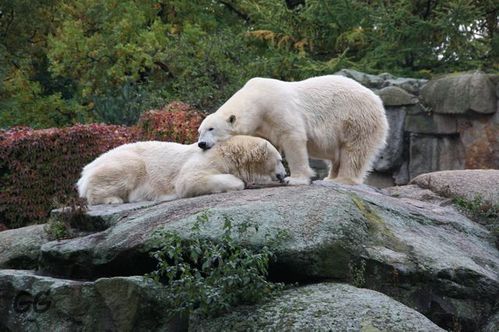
[282,138,314,186]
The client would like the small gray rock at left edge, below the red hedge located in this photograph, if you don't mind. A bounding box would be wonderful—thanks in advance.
[0,225,49,269]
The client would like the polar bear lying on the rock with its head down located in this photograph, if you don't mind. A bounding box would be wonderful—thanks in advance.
[77,136,286,205]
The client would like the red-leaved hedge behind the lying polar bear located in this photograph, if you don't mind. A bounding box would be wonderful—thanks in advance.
[0,102,202,228]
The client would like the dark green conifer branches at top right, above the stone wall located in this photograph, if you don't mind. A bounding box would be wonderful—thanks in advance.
[241,0,499,75]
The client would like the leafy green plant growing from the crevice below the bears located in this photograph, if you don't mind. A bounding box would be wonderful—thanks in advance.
[148,213,283,316]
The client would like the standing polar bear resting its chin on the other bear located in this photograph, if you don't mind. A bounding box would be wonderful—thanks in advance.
[198,75,388,185]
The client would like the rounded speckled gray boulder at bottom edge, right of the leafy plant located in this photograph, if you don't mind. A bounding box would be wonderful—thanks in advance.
[189,283,444,332]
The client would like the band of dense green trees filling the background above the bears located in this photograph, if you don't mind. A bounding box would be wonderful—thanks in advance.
[0,0,499,127]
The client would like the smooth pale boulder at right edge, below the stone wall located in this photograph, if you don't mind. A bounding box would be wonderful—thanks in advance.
[411,169,499,204]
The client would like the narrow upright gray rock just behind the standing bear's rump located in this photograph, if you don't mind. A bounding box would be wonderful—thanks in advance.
[373,107,406,172]
